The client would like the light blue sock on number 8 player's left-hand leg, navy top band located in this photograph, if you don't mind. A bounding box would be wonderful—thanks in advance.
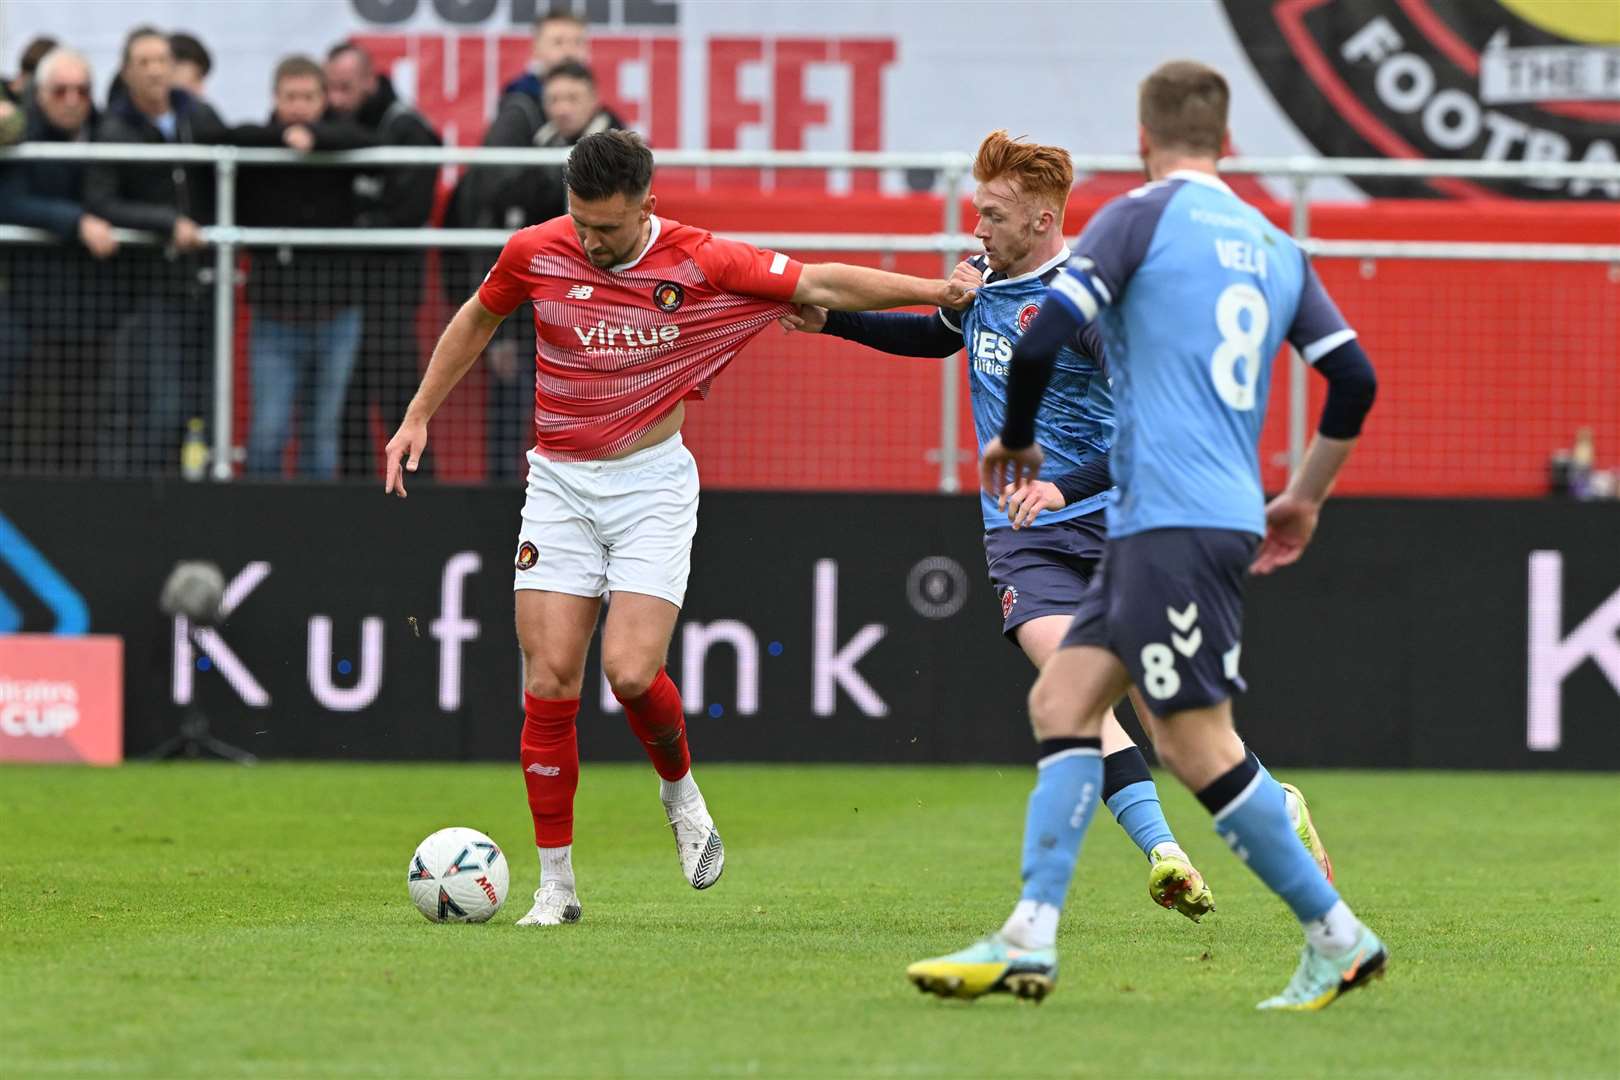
[1021,738,1108,908]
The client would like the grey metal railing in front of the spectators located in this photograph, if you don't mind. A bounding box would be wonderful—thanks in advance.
[9,142,1620,492]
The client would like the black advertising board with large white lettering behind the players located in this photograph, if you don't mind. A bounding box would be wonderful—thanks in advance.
[0,481,1620,769]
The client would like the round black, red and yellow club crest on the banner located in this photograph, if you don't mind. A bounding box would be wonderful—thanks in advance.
[1221,0,1620,199]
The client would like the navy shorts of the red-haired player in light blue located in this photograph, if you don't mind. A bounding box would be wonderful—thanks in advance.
[985,510,1108,644]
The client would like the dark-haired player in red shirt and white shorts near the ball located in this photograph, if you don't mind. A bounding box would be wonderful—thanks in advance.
[386,131,970,926]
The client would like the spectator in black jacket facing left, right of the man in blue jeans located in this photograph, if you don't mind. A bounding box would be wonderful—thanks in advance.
[326,40,441,478]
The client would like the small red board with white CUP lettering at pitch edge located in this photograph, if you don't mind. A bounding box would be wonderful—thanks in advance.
[0,633,123,764]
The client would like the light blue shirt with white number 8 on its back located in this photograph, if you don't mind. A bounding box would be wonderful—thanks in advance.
[1037,170,1356,536]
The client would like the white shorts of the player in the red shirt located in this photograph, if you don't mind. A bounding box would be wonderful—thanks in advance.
[512,432,698,607]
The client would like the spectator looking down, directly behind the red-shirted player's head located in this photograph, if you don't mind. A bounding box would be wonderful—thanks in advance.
[484,60,622,479]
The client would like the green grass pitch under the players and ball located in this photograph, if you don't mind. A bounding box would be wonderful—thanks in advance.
[0,764,1620,1080]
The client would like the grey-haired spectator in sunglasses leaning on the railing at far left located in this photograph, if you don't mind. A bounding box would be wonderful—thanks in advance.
[0,49,118,470]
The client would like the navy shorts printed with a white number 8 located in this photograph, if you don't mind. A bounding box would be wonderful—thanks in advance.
[1063,529,1260,716]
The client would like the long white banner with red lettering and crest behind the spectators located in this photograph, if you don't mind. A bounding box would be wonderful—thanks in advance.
[0,0,1620,199]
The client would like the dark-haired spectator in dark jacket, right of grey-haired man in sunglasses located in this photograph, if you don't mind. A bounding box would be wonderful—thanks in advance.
[84,26,222,473]
